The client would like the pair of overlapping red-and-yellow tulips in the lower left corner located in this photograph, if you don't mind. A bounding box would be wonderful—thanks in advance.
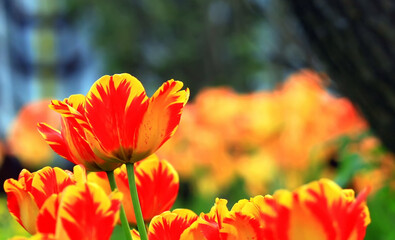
[4,165,122,239]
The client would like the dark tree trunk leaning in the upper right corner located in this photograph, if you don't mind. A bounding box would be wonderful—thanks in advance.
[285,0,395,152]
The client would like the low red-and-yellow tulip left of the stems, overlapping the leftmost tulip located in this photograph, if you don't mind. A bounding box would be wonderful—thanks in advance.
[14,182,122,240]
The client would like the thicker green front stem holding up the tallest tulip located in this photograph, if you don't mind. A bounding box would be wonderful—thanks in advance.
[126,163,148,240]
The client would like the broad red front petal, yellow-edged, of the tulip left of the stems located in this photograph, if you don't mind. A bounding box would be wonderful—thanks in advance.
[56,182,122,240]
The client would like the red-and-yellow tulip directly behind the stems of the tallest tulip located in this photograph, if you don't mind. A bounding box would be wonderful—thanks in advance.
[88,154,179,224]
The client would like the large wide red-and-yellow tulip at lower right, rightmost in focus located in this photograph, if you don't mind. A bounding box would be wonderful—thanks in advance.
[231,179,370,240]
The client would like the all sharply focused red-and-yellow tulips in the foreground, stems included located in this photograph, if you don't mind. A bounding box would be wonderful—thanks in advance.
[4,74,370,240]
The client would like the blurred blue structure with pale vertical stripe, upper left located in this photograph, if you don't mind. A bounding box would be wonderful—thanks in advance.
[0,0,100,138]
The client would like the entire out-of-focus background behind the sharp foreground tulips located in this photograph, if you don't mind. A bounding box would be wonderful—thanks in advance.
[0,0,395,239]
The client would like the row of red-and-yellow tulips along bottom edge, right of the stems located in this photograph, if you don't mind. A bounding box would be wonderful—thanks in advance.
[134,179,370,240]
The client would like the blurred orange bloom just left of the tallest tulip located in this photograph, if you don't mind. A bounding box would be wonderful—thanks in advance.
[7,100,60,169]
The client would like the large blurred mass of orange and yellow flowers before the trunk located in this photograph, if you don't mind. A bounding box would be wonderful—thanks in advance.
[158,70,367,195]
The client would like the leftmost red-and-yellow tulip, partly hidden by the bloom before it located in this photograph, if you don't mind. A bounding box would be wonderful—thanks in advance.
[4,167,76,234]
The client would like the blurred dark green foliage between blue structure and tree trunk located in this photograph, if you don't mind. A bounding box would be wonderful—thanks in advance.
[62,0,305,95]
